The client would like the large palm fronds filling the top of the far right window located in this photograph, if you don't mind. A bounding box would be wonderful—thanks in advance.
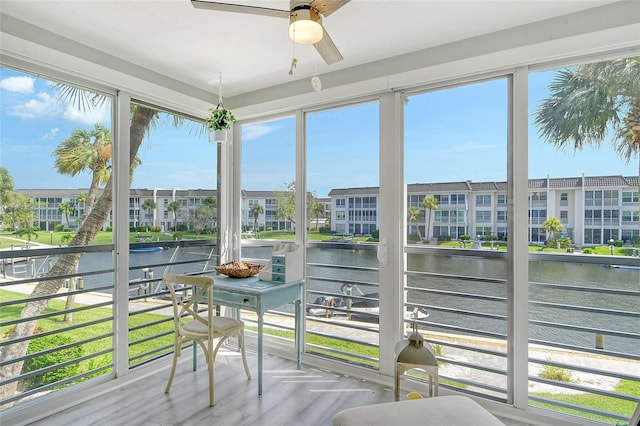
[534,56,640,236]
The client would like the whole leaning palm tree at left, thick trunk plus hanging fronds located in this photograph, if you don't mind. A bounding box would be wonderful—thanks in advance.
[0,85,160,399]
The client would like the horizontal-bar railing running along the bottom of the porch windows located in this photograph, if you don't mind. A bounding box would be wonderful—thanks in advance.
[0,240,640,423]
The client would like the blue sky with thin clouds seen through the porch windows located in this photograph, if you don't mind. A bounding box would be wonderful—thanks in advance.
[0,68,638,197]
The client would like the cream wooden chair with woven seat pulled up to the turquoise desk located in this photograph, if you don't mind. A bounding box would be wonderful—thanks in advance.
[163,274,251,406]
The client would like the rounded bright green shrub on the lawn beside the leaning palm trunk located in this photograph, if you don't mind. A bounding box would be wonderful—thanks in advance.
[22,334,84,389]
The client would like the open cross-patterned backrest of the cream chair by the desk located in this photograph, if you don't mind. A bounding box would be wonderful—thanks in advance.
[162,274,213,333]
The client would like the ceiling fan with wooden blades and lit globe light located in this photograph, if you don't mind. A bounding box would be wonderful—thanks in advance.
[191,0,350,65]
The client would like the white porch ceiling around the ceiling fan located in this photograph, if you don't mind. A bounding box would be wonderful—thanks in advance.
[0,0,640,116]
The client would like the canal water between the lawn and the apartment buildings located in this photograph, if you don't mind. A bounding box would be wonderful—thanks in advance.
[7,245,640,357]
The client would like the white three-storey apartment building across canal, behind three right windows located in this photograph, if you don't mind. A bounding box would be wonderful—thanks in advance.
[329,176,639,245]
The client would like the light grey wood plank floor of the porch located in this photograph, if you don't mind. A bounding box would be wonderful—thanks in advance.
[32,352,393,426]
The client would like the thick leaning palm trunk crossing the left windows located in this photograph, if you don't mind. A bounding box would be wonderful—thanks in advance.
[0,106,156,402]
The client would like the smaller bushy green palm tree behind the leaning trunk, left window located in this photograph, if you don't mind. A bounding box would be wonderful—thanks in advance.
[53,123,111,222]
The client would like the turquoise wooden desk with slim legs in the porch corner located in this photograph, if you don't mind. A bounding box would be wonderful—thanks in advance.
[193,275,304,395]
